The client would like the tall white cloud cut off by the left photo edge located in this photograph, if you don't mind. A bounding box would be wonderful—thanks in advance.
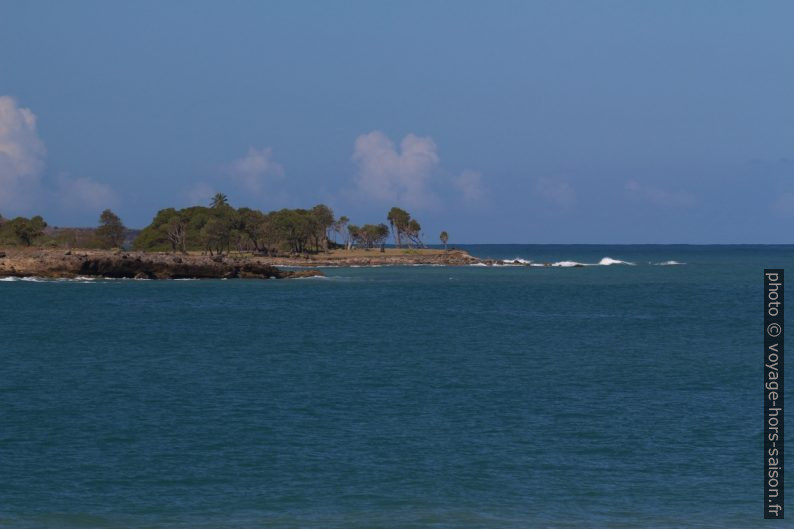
[0,96,46,210]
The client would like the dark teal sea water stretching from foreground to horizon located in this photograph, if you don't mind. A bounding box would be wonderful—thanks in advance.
[0,245,794,529]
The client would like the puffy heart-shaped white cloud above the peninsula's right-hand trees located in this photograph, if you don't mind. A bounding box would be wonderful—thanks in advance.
[353,130,439,207]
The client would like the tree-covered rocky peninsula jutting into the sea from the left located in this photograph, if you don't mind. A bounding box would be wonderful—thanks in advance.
[0,197,481,279]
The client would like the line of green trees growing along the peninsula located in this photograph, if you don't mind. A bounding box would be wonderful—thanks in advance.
[0,193,446,255]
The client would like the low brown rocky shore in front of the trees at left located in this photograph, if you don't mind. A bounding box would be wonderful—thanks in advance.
[0,250,323,279]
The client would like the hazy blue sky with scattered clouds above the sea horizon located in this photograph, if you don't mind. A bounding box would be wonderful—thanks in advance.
[0,0,794,244]
